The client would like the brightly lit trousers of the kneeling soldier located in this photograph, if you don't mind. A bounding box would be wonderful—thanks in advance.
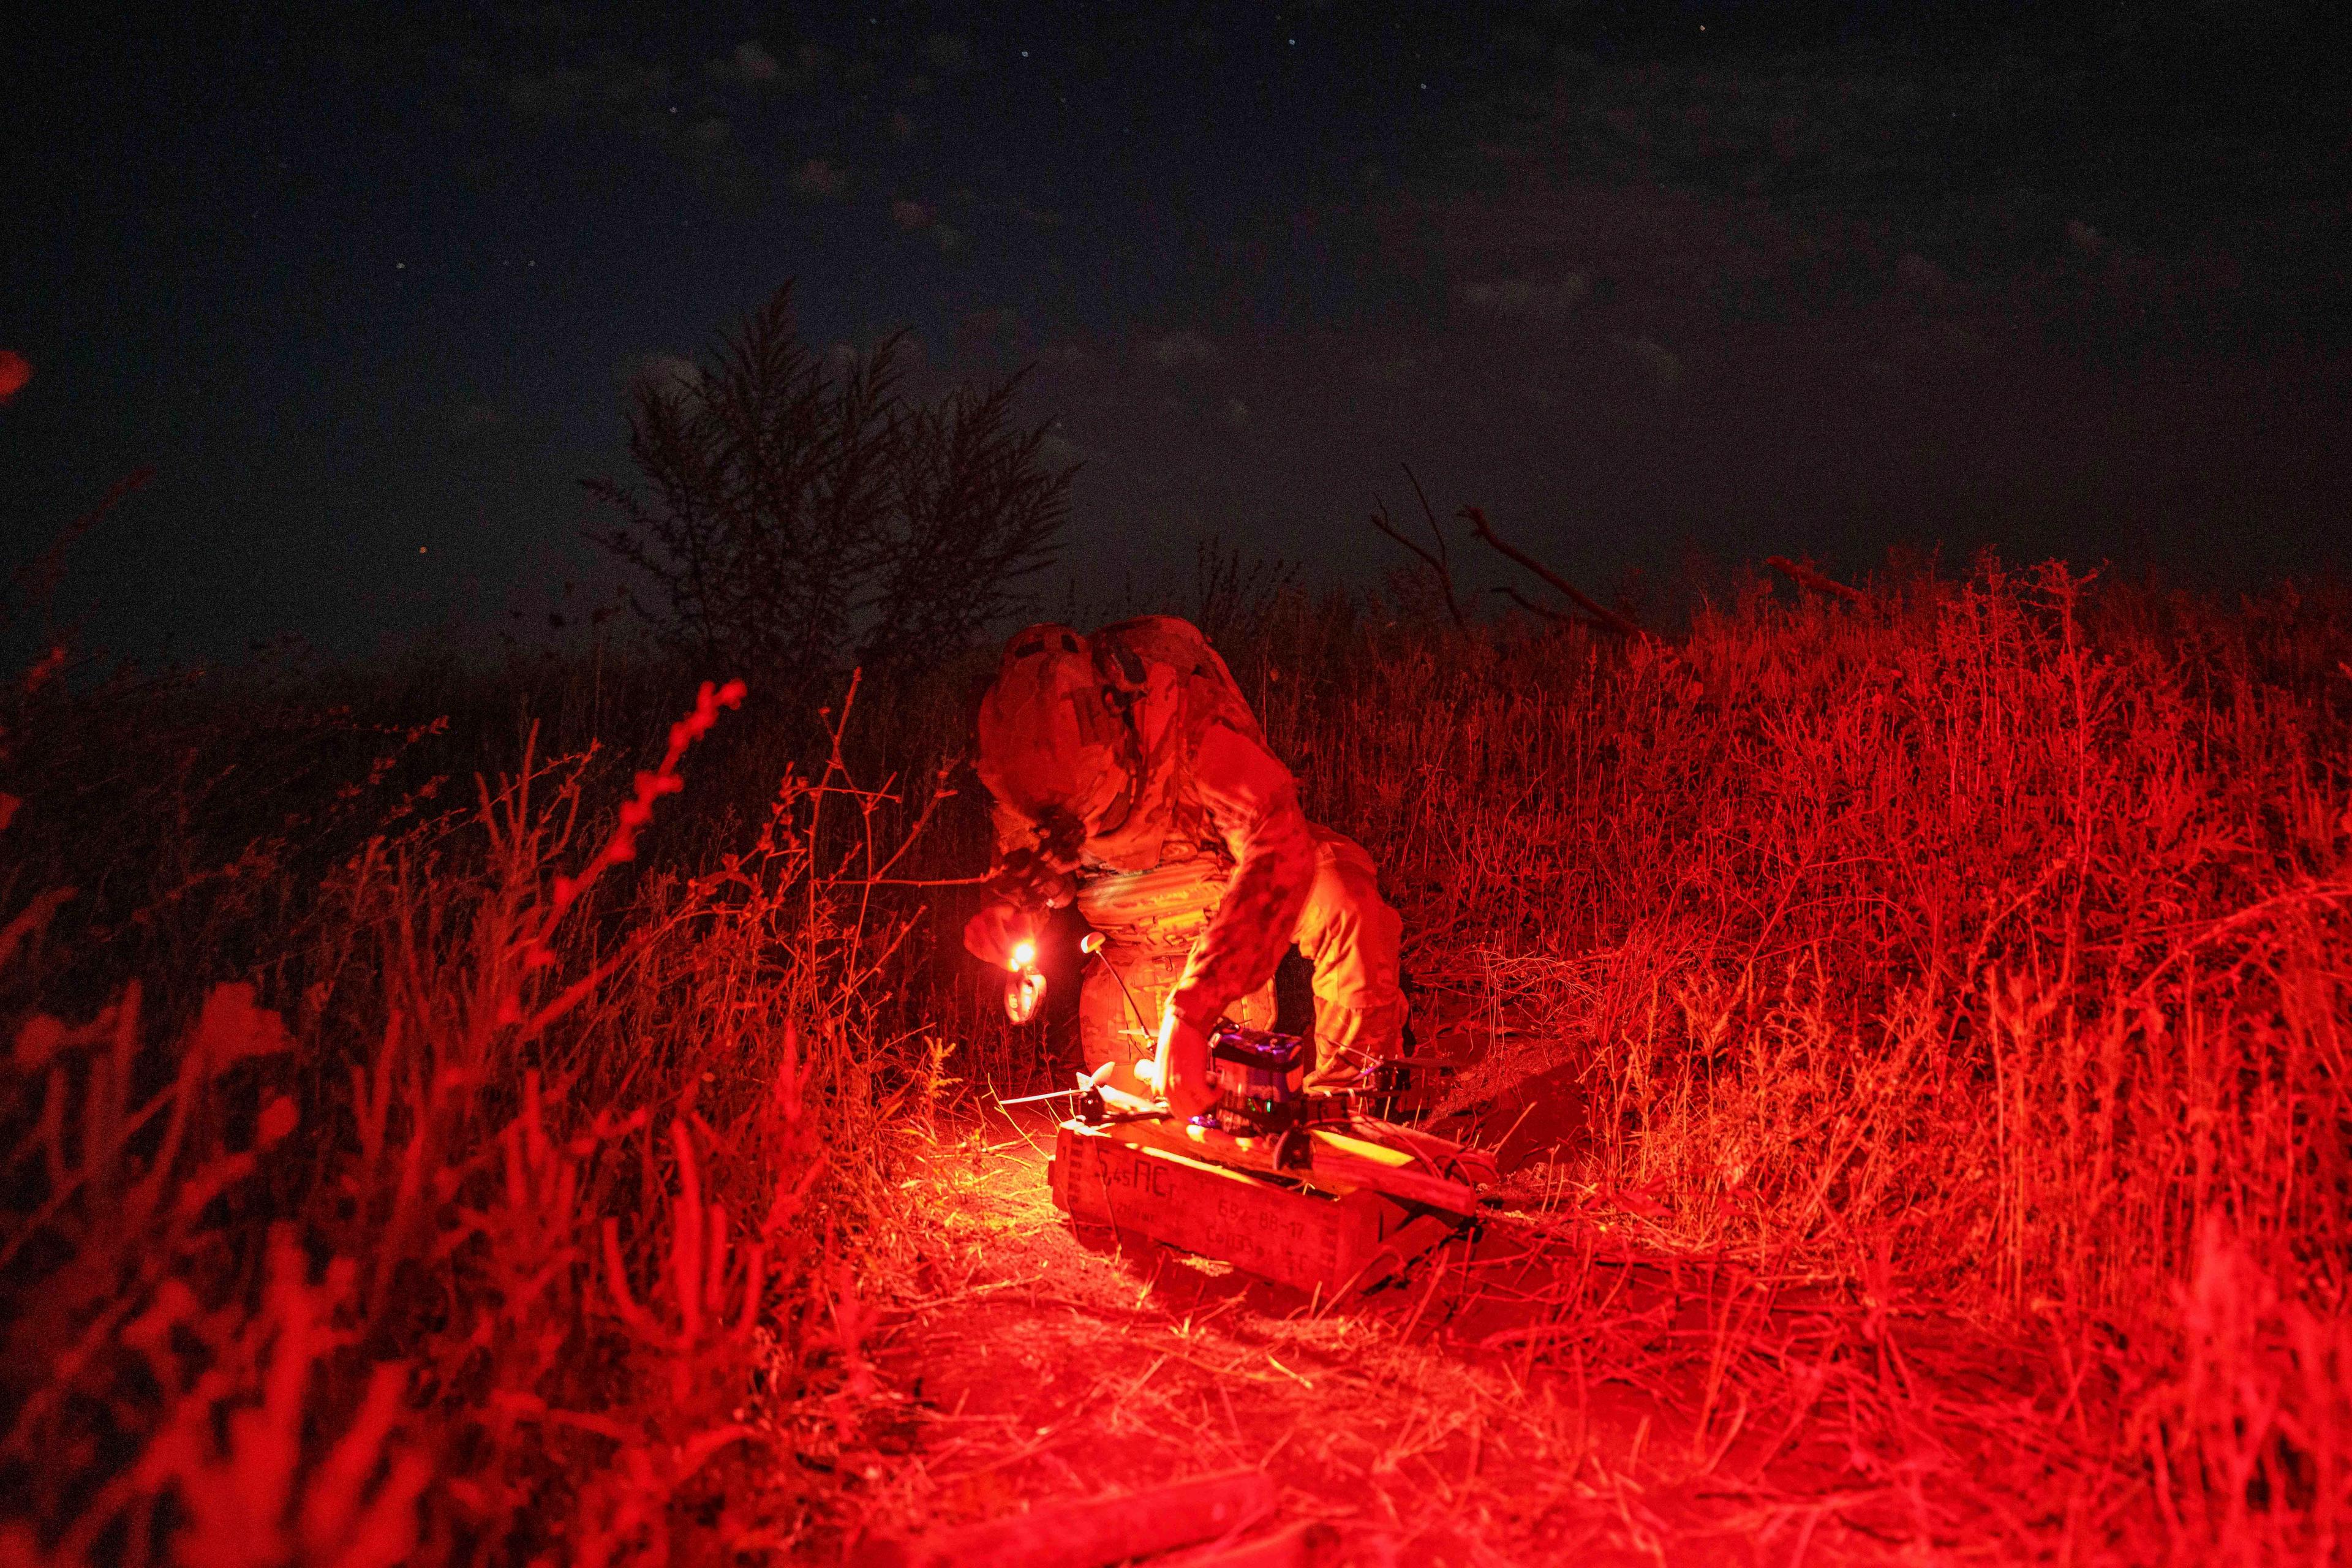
[1077,827,1404,1088]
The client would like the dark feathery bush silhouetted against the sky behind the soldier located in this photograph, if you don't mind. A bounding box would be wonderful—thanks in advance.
[588,284,1075,691]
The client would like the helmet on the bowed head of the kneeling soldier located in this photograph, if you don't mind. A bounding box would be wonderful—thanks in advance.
[978,623,1134,846]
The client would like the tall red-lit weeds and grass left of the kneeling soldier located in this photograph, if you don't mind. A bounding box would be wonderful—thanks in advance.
[0,668,943,1563]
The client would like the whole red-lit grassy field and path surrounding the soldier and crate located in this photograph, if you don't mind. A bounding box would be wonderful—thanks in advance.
[0,567,2352,1566]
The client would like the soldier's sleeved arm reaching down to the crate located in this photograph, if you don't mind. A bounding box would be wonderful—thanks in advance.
[1169,724,1315,1030]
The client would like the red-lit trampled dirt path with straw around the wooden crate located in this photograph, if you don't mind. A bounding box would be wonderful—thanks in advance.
[832,1107,2108,1568]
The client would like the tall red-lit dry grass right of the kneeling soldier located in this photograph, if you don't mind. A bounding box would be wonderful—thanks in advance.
[1244,564,2352,1561]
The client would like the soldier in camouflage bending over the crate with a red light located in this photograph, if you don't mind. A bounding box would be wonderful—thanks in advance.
[964,616,1404,1117]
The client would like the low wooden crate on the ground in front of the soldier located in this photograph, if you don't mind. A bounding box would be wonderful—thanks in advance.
[1047,1121,1463,1300]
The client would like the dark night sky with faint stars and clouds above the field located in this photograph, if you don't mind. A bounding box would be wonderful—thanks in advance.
[0,0,2352,658]
